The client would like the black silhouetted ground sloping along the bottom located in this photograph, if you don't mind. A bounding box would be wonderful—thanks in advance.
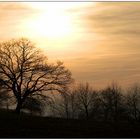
[0,111,140,138]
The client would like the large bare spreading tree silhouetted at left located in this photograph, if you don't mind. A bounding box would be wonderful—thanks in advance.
[0,38,72,113]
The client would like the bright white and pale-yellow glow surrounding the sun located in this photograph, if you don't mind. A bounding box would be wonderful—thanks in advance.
[20,2,95,56]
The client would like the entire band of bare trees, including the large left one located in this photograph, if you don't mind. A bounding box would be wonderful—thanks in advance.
[0,38,140,121]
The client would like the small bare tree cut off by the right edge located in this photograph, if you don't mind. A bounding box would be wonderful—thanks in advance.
[126,84,140,121]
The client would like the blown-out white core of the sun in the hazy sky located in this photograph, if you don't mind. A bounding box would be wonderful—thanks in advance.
[30,13,71,38]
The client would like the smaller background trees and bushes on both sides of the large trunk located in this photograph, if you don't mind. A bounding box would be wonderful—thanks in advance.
[0,83,140,121]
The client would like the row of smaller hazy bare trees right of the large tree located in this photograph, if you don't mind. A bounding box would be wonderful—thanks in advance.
[47,83,140,121]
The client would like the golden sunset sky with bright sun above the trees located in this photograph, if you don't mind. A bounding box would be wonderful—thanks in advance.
[0,2,140,88]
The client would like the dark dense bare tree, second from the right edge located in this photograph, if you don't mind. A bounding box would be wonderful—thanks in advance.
[100,83,123,121]
